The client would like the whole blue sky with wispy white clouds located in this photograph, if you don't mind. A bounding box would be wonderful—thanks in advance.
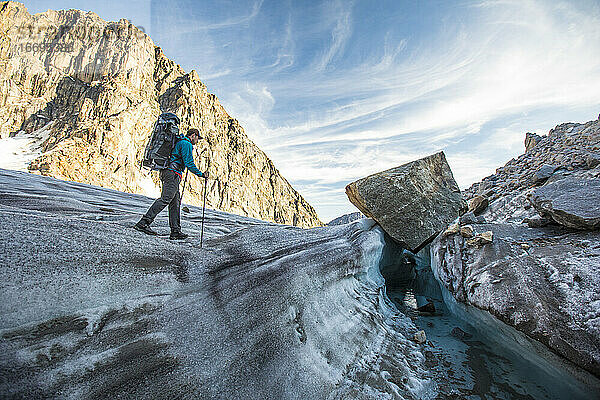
[24,0,600,222]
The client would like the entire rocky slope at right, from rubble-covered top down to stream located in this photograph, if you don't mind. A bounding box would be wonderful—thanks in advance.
[431,116,600,376]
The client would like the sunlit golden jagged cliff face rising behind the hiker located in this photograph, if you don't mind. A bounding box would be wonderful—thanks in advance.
[0,2,321,227]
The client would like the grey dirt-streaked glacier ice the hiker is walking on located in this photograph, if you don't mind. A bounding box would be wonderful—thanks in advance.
[0,169,435,399]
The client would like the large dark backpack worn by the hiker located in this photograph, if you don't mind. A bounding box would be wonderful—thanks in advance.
[142,113,180,170]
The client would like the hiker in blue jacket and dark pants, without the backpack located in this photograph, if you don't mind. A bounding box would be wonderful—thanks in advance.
[134,128,208,240]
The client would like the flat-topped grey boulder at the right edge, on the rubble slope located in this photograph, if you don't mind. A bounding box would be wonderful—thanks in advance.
[532,176,600,230]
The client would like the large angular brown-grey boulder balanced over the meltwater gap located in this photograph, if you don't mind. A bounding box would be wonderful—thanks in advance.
[346,152,466,253]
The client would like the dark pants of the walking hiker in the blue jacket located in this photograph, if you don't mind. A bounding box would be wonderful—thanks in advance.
[142,169,181,232]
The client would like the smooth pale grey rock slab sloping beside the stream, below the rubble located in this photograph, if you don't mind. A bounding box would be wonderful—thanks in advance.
[431,219,600,376]
